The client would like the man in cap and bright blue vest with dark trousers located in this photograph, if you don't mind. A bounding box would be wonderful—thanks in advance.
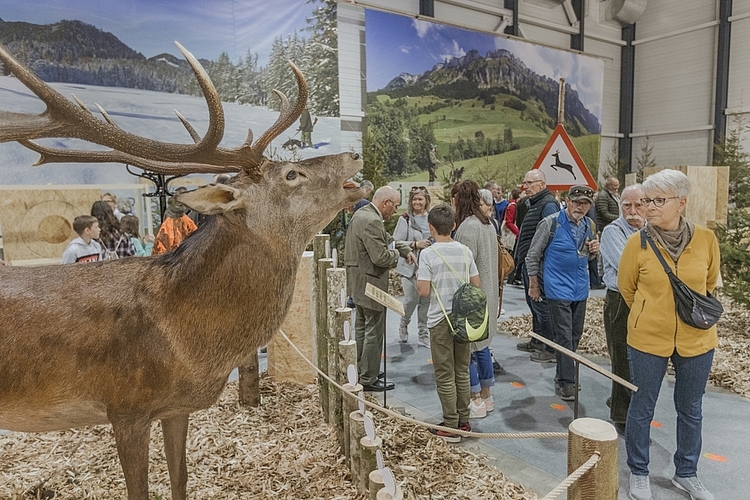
[526,185,599,401]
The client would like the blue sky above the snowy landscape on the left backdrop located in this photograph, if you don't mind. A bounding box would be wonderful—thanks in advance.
[0,0,320,65]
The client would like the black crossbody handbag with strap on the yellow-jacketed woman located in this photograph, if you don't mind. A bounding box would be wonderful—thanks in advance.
[641,229,724,330]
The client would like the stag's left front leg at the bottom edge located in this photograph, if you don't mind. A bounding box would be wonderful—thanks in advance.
[110,417,151,500]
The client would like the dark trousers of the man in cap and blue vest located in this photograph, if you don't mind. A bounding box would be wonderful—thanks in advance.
[547,299,586,387]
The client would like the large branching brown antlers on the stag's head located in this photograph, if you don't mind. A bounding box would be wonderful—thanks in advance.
[0,42,307,177]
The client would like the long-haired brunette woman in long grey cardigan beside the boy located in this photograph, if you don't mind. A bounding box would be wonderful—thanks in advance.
[451,180,500,418]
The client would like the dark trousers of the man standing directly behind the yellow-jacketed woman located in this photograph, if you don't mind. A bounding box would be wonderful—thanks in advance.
[604,289,630,424]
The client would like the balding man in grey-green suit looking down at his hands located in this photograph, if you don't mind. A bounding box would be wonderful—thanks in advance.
[344,186,415,392]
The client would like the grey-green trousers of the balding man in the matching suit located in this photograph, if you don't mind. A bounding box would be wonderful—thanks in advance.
[354,304,385,385]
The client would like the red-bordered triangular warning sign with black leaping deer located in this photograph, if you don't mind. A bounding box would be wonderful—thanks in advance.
[531,124,597,191]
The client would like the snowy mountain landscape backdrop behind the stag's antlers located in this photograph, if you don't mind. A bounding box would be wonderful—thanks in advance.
[0,0,341,185]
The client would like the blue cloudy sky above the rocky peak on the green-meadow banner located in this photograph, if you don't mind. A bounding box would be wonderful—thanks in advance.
[365,9,604,122]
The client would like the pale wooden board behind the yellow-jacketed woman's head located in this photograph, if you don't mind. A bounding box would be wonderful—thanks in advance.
[643,165,729,229]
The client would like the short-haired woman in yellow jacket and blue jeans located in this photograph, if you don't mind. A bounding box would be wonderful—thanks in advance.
[617,170,719,500]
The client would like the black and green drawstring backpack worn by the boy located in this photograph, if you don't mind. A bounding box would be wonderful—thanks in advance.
[432,248,489,344]
